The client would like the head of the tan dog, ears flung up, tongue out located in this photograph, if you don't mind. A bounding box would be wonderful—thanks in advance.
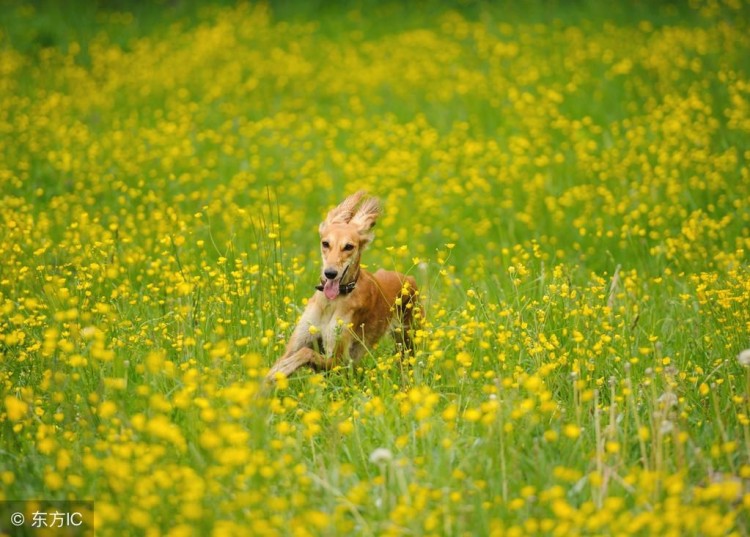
[319,190,380,300]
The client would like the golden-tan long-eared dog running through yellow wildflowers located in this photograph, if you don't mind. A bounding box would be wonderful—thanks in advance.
[266,191,424,383]
